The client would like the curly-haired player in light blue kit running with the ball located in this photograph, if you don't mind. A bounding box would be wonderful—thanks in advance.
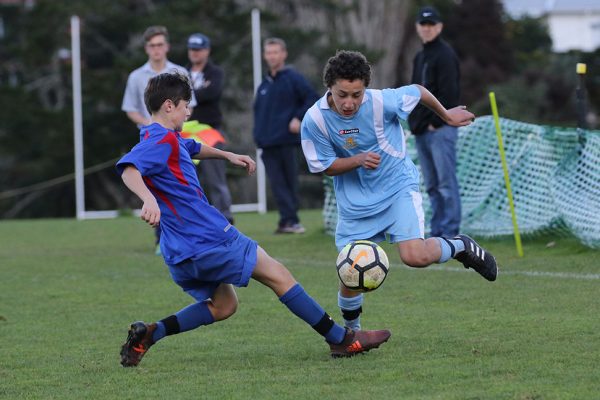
[301,51,498,330]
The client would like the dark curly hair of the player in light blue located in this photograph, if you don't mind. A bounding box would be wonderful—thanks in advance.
[323,50,371,88]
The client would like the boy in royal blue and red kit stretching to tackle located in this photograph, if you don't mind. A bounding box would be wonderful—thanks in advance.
[117,73,390,367]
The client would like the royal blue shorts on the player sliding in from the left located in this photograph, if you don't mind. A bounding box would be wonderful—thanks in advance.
[168,232,258,302]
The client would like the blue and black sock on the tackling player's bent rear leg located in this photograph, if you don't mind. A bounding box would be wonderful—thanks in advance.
[152,301,215,342]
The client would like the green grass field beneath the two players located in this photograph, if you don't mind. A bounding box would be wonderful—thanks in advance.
[0,211,600,400]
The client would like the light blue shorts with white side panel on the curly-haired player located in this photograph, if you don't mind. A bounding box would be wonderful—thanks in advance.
[335,185,425,251]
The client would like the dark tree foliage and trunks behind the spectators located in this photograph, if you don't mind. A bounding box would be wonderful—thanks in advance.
[0,0,600,217]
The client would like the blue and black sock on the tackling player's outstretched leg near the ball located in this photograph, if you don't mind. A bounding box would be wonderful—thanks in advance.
[279,283,346,343]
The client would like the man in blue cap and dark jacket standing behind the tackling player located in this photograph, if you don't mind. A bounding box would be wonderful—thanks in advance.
[187,33,233,224]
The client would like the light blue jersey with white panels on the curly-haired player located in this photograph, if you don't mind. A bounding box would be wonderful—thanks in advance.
[301,85,421,220]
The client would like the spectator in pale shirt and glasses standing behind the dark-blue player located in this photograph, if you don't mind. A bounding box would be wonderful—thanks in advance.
[121,26,196,255]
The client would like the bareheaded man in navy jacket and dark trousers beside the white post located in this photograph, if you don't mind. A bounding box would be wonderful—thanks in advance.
[254,38,319,233]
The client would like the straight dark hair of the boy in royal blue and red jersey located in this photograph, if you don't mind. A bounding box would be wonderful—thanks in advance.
[144,71,192,114]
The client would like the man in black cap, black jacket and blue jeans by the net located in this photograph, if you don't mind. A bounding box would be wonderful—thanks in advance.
[408,7,461,238]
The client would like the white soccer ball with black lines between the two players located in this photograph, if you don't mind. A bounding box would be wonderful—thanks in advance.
[336,240,390,292]
